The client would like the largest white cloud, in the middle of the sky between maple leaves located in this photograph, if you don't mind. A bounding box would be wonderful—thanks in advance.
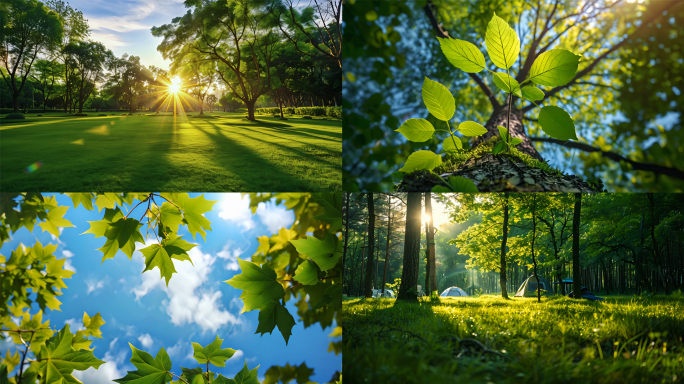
[133,247,242,331]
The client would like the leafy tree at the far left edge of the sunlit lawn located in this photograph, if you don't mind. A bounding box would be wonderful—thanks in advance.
[0,0,64,113]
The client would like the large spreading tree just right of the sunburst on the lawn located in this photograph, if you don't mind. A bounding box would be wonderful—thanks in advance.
[152,0,279,121]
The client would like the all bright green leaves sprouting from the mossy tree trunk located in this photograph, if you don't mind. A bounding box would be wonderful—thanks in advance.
[397,14,580,184]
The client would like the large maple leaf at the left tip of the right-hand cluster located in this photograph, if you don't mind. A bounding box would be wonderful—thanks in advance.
[224,259,285,313]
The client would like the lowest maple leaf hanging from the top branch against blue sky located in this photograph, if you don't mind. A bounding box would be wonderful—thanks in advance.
[140,235,196,286]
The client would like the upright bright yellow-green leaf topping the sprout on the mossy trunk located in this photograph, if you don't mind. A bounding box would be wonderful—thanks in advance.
[485,13,520,69]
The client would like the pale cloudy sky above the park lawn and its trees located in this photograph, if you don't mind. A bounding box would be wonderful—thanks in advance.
[69,0,187,69]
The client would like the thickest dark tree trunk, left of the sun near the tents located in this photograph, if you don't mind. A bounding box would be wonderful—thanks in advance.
[397,193,422,302]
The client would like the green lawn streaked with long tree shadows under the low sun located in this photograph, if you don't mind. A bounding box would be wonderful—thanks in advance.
[0,112,342,192]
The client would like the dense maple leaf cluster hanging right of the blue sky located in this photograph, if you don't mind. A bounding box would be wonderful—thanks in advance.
[226,193,342,353]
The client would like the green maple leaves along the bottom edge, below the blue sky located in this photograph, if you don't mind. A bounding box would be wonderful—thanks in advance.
[114,336,259,384]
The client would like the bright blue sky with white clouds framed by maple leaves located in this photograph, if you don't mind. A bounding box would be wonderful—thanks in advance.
[0,193,342,384]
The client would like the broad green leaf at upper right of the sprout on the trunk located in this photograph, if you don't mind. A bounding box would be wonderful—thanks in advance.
[530,49,582,87]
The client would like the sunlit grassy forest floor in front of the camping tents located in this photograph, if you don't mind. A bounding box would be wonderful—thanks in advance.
[342,293,684,384]
